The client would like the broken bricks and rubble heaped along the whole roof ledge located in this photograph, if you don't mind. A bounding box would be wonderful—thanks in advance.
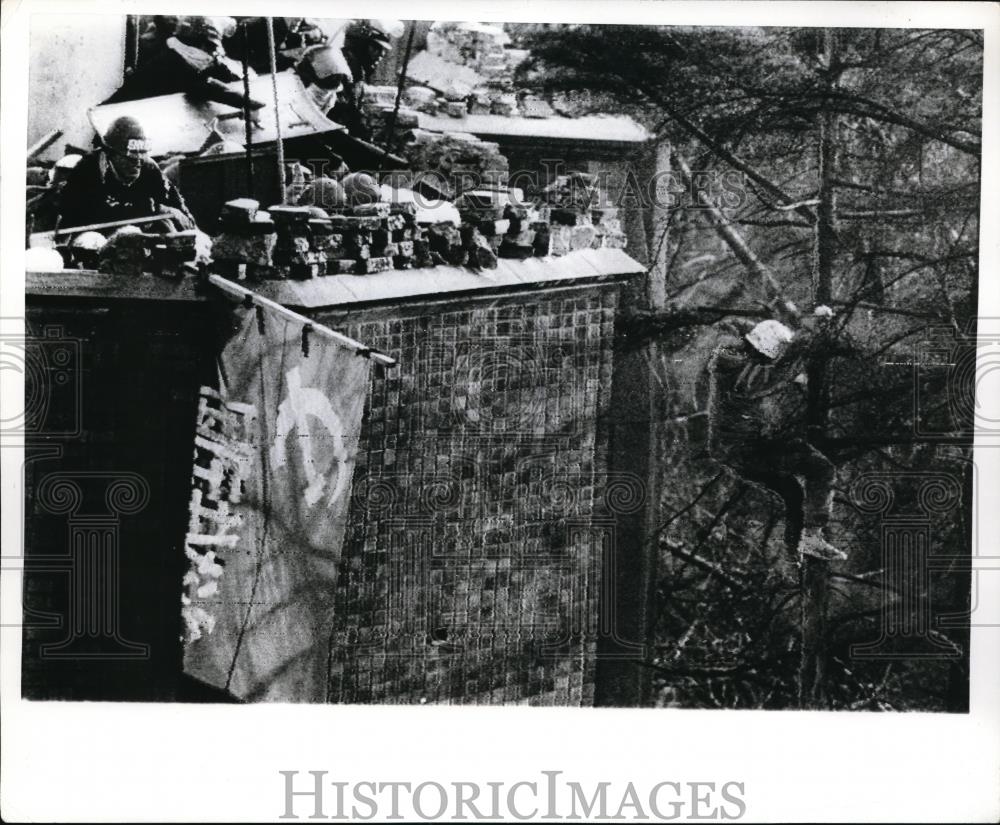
[48,153,625,281]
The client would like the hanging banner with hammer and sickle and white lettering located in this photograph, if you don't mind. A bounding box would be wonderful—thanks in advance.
[181,307,370,702]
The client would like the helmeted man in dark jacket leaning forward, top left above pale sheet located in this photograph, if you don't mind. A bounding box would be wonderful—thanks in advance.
[104,16,243,106]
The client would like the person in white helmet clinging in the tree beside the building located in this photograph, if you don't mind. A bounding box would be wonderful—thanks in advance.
[708,306,847,561]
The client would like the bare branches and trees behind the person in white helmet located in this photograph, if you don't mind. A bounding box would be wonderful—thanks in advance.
[515,25,983,710]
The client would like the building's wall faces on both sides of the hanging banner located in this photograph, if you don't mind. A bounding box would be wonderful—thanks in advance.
[22,272,643,705]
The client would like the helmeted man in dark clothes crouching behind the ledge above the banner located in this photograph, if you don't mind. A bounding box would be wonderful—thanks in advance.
[59,117,195,229]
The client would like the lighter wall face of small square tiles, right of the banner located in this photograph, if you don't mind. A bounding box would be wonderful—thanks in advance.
[319,286,618,705]
